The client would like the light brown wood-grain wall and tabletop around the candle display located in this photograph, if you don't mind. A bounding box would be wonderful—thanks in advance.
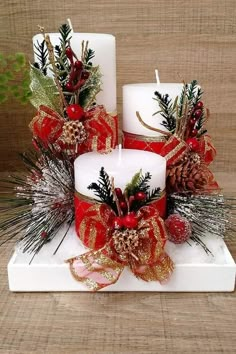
[0,0,236,354]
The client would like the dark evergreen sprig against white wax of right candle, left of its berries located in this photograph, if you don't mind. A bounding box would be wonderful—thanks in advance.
[153,91,177,132]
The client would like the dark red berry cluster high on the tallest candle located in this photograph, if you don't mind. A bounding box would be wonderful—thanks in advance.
[65,47,89,92]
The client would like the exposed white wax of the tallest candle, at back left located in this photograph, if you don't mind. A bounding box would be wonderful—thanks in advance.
[33,32,116,112]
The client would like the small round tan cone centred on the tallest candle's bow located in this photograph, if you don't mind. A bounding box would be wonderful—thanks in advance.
[61,121,87,145]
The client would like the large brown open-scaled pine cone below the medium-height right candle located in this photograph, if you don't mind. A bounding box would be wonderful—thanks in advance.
[167,152,209,193]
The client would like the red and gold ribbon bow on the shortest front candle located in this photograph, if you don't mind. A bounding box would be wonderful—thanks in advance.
[67,196,173,291]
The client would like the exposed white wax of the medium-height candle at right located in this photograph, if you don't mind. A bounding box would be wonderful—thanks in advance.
[123,83,183,137]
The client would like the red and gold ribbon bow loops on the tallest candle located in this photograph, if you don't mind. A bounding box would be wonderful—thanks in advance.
[29,105,118,155]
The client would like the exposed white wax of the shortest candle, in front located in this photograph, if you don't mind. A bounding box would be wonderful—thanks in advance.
[74,149,166,199]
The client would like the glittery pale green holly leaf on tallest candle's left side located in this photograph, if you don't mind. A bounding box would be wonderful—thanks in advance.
[30,65,62,114]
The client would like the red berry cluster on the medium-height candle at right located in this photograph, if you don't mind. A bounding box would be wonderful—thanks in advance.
[186,101,203,152]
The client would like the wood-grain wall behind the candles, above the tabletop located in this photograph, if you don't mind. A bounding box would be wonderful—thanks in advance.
[0,0,236,172]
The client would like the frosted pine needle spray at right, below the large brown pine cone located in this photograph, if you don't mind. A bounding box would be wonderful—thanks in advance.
[168,193,236,252]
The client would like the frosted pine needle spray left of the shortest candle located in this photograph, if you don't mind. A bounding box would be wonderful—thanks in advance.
[0,144,74,255]
